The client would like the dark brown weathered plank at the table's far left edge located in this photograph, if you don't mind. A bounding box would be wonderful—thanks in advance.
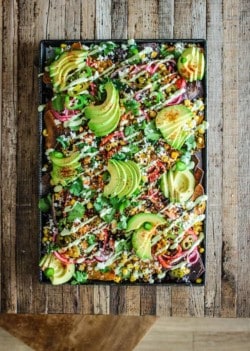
[1,1,18,313]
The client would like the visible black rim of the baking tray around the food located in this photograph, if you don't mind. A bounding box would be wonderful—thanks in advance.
[38,39,208,286]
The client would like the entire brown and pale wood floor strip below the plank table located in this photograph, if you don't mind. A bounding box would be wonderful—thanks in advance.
[0,314,250,351]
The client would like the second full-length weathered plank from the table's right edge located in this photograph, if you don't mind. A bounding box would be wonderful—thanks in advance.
[221,1,239,317]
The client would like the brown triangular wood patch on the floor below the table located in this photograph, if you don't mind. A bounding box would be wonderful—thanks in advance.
[0,315,156,351]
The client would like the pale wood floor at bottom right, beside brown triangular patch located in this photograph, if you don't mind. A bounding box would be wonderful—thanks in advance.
[134,318,250,351]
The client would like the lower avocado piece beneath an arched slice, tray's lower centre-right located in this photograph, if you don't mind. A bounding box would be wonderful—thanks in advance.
[132,227,155,260]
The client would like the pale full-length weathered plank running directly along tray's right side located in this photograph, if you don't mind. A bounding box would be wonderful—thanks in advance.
[205,1,223,317]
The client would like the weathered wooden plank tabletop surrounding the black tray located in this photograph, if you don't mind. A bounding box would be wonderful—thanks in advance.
[0,0,250,317]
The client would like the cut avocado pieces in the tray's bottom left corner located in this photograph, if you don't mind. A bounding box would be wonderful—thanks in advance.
[39,253,75,285]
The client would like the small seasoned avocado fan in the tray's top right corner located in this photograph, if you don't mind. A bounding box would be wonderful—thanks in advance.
[177,46,205,82]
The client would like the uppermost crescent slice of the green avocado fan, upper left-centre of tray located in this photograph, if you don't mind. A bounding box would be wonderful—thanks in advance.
[84,82,119,119]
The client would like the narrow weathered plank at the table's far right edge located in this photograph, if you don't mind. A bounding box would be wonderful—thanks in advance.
[236,0,250,317]
